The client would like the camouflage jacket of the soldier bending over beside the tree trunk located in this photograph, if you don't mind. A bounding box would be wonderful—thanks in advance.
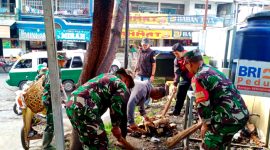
[72,74,127,126]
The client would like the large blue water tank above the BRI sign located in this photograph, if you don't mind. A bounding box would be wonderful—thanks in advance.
[232,11,270,62]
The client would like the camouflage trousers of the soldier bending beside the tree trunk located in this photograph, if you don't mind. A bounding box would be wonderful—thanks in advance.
[66,97,108,150]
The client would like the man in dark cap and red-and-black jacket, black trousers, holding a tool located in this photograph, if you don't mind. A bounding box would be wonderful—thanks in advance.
[169,43,192,116]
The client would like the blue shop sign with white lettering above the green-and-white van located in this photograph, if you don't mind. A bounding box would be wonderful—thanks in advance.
[19,28,90,42]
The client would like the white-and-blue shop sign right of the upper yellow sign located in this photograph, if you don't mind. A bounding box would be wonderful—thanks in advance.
[168,15,223,27]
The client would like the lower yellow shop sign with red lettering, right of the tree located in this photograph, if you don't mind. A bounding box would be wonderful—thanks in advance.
[121,29,172,39]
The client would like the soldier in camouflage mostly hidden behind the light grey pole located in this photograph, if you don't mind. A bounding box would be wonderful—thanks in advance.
[42,52,67,150]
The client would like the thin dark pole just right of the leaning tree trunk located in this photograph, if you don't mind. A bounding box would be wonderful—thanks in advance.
[124,0,129,69]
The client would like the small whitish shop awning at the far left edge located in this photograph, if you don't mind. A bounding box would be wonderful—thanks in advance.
[0,20,15,38]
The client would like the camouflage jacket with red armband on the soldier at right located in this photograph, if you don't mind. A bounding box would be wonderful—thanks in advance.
[192,65,249,124]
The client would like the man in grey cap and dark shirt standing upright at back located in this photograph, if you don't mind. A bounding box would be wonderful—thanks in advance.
[135,38,156,106]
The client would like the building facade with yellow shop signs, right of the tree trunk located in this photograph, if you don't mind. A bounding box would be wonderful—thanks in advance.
[122,0,233,46]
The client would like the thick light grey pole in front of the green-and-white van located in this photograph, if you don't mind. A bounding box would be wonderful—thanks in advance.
[42,0,64,150]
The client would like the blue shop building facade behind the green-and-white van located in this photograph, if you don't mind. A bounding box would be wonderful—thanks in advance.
[0,0,94,57]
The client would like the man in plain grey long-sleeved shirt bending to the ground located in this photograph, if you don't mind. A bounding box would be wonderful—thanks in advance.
[127,80,166,130]
